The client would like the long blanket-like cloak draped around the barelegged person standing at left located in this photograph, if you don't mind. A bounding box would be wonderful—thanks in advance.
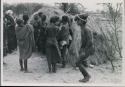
[16,24,35,59]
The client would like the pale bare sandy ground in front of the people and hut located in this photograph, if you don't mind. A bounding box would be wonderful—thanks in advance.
[3,51,122,85]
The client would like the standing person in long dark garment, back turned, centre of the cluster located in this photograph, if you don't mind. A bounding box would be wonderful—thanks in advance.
[46,16,61,73]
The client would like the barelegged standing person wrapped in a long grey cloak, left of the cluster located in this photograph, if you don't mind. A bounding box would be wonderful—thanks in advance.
[16,19,35,73]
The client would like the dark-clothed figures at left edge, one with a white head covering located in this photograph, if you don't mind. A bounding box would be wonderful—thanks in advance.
[3,10,17,56]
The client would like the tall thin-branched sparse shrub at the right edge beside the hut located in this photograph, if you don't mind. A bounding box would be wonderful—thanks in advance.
[100,3,122,70]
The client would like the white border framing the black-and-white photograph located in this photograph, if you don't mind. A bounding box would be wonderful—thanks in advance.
[1,0,125,87]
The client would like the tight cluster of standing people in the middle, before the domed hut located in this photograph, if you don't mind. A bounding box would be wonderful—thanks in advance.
[31,12,72,72]
